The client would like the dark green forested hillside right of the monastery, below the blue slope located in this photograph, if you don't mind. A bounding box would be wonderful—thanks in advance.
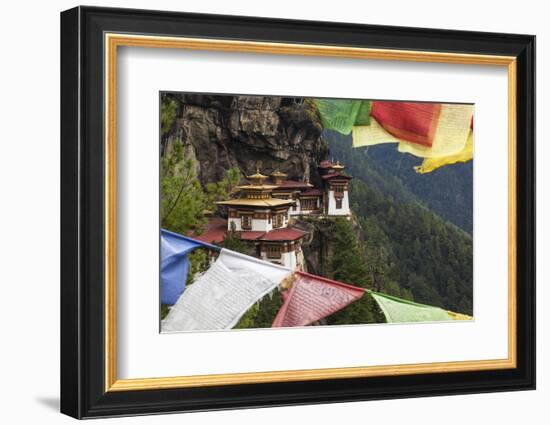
[350,180,473,314]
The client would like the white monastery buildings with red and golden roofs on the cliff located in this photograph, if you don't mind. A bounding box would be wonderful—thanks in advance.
[197,161,351,270]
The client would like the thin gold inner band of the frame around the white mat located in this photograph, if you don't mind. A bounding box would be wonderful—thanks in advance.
[105,33,517,391]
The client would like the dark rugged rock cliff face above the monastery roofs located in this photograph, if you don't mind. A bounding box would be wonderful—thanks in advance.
[162,94,328,185]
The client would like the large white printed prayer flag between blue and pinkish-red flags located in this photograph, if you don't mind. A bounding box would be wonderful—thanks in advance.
[162,249,291,332]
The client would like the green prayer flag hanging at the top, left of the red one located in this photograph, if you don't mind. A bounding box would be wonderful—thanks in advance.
[314,99,370,134]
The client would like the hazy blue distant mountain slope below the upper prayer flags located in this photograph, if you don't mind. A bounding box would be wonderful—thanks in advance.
[323,131,473,234]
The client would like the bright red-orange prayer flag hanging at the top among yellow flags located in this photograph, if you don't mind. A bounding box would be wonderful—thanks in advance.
[371,101,441,147]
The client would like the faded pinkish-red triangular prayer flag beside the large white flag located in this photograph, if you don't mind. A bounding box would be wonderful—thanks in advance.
[271,272,365,328]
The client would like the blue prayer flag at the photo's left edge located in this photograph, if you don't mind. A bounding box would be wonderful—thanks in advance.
[160,229,219,305]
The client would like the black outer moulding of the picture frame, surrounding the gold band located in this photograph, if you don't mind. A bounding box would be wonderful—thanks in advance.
[61,7,535,418]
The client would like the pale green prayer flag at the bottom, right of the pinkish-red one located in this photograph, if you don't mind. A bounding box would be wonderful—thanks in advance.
[369,291,453,323]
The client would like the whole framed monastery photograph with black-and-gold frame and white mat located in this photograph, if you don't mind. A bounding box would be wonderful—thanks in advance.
[61,7,535,418]
